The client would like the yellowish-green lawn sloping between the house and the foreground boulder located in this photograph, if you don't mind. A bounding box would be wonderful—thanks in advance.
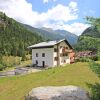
[0,63,100,100]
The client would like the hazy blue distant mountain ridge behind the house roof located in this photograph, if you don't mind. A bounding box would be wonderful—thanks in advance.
[24,25,78,45]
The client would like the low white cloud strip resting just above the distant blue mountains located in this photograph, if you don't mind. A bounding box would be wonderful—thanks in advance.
[44,22,90,36]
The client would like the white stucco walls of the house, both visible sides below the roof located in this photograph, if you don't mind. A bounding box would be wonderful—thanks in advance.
[32,41,70,67]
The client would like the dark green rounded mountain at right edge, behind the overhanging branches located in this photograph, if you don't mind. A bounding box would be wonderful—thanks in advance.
[75,27,100,52]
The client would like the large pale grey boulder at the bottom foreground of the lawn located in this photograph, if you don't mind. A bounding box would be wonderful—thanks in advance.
[25,86,90,100]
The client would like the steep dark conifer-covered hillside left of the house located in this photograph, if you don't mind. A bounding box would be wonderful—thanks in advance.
[0,12,43,56]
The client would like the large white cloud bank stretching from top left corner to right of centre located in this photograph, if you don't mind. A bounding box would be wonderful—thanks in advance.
[0,0,77,25]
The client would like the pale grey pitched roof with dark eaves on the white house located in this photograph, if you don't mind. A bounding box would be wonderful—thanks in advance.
[28,39,72,49]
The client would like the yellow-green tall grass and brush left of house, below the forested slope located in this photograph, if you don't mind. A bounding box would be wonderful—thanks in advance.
[0,55,31,71]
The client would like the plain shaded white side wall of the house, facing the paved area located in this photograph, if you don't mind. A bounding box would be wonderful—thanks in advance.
[32,48,54,67]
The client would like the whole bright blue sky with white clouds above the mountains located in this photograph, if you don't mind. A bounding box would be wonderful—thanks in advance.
[0,0,100,35]
